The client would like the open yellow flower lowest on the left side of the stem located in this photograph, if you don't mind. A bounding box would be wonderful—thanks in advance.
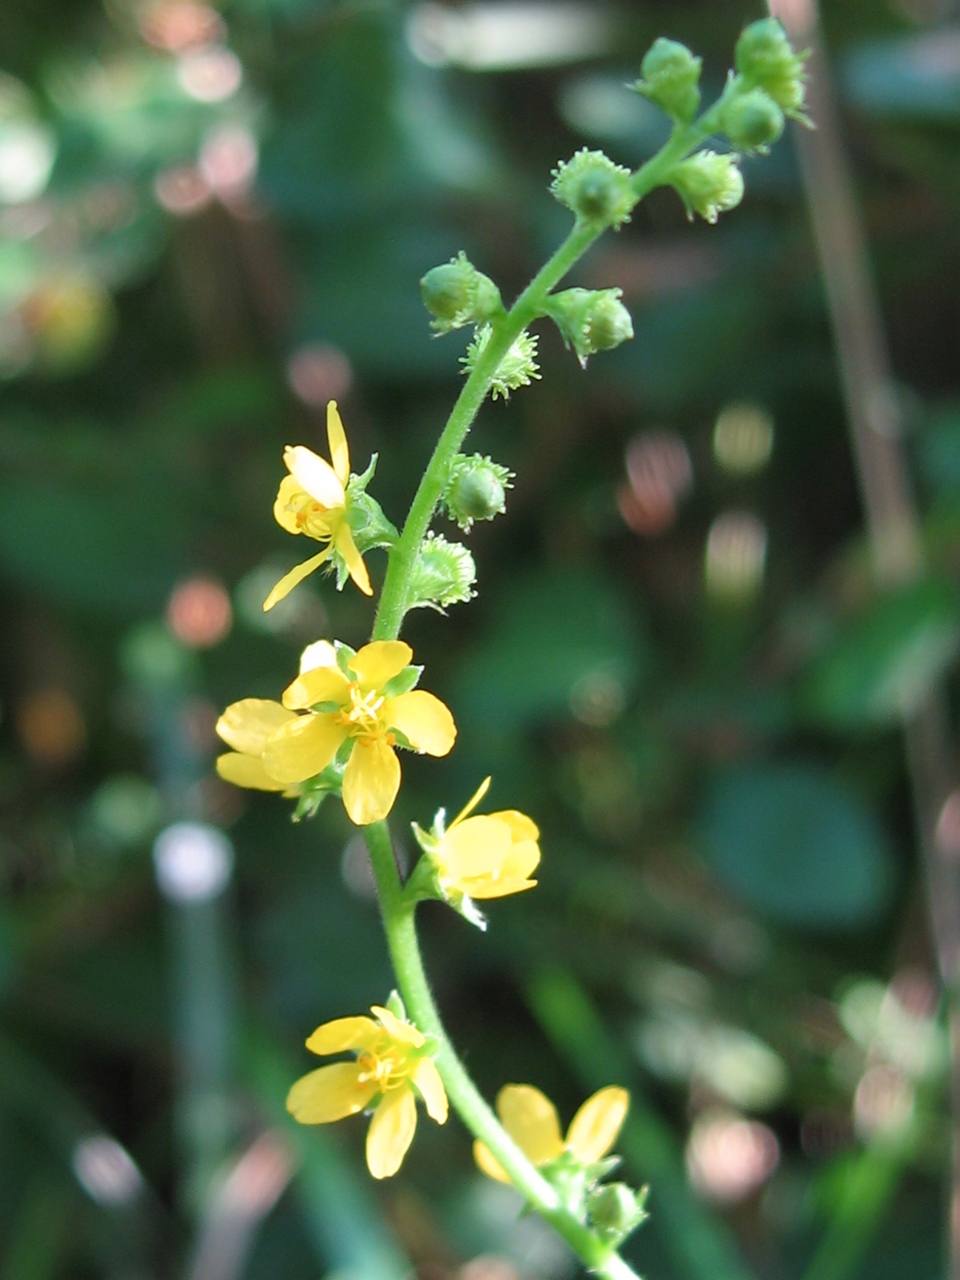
[287,1005,447,1178]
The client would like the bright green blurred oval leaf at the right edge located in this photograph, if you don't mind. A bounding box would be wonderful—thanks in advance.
[803,580,960,730]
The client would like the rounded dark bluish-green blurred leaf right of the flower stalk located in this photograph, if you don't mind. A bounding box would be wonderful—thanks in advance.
[701,764,892,928]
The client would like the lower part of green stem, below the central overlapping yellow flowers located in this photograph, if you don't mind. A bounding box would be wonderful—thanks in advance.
[365,822,637,1280]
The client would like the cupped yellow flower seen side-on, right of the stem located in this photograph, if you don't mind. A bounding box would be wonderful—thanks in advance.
[413,778,540,900]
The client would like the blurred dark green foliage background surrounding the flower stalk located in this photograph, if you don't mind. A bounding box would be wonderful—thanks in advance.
[0,0,960,1280]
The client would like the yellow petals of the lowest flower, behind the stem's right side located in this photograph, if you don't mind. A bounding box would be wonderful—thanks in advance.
[474,1084,630,1183]
